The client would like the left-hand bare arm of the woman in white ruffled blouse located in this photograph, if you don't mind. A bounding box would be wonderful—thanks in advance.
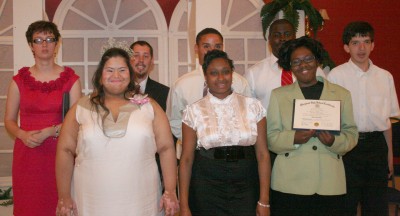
[179,123,197,216]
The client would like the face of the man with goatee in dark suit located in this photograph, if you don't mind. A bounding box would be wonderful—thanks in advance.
[131,44,154,79]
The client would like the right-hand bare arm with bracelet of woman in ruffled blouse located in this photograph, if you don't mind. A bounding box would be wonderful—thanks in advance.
[255,118,271,215]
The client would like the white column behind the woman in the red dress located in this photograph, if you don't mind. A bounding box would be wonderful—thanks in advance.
[13,0,45,73]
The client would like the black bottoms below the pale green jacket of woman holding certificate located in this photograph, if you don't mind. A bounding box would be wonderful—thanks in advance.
[270,190,345,216]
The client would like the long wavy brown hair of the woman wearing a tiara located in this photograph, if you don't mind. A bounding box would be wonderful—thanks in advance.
[90,48,140,132]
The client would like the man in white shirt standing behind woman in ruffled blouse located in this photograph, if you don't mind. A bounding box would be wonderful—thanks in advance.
[167,28,251,158]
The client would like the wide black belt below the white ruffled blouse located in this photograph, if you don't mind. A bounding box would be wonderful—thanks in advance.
[197,146,255,162]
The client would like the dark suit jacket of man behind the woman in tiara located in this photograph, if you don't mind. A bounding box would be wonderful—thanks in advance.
[144,77,169,112]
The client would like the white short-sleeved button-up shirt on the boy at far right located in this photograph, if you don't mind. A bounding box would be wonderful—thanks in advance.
[328,59,400,132]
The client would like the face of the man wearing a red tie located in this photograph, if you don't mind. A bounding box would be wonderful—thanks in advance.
[268,23,296,57]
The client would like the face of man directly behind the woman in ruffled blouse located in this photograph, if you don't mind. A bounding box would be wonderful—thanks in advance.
[194,34,224,65]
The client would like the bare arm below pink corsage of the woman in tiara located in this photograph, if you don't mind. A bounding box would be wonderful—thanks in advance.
[151,100,179,215]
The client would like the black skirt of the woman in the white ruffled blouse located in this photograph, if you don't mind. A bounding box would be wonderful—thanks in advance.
[189,146,260,216]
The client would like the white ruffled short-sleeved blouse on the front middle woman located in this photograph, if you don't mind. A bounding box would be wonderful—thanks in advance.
[182,92,266,149]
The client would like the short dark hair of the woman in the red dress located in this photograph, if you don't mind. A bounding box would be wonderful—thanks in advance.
[25,20,61,43]
